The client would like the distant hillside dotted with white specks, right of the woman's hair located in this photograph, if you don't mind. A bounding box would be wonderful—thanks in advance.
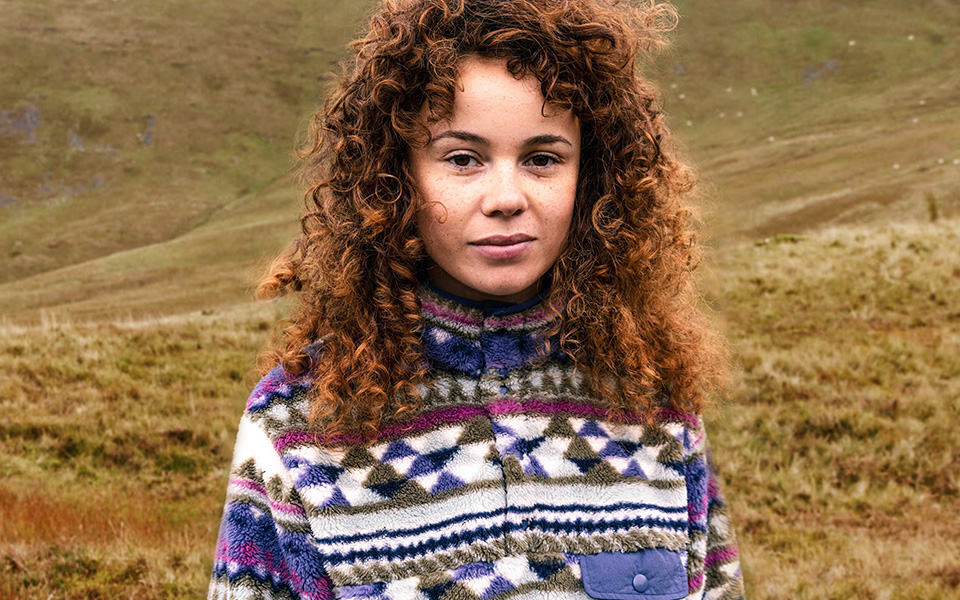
[663,0,960,243]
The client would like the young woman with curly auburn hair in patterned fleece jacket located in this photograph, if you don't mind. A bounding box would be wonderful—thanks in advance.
[209,0,743,600]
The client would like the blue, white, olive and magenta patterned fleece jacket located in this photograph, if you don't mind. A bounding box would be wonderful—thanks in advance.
[209,288,743,600]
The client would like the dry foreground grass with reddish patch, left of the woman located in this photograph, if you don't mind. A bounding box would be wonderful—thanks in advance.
[0,307,277,598]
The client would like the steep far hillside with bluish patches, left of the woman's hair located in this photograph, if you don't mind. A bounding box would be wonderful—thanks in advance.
[0,0,367,286]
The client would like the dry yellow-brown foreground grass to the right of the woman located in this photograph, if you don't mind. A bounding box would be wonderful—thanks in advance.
[710,220,960,600]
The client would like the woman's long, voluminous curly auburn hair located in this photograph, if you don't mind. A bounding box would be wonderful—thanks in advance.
[257,0,724,439]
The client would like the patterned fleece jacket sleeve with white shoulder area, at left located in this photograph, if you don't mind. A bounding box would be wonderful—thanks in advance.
[207,413,333,600]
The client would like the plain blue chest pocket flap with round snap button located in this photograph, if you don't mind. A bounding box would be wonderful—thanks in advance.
[579,548,688,600]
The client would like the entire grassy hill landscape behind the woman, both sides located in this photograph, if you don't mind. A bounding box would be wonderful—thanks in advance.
[0,0,960,599]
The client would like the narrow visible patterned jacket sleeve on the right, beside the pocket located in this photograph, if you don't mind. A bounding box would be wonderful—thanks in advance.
[686,417,744,600]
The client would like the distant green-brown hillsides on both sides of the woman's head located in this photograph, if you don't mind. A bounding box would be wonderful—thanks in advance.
[0,0,960,323]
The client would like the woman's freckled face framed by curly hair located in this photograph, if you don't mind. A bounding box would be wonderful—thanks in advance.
[410,58,580,302]
